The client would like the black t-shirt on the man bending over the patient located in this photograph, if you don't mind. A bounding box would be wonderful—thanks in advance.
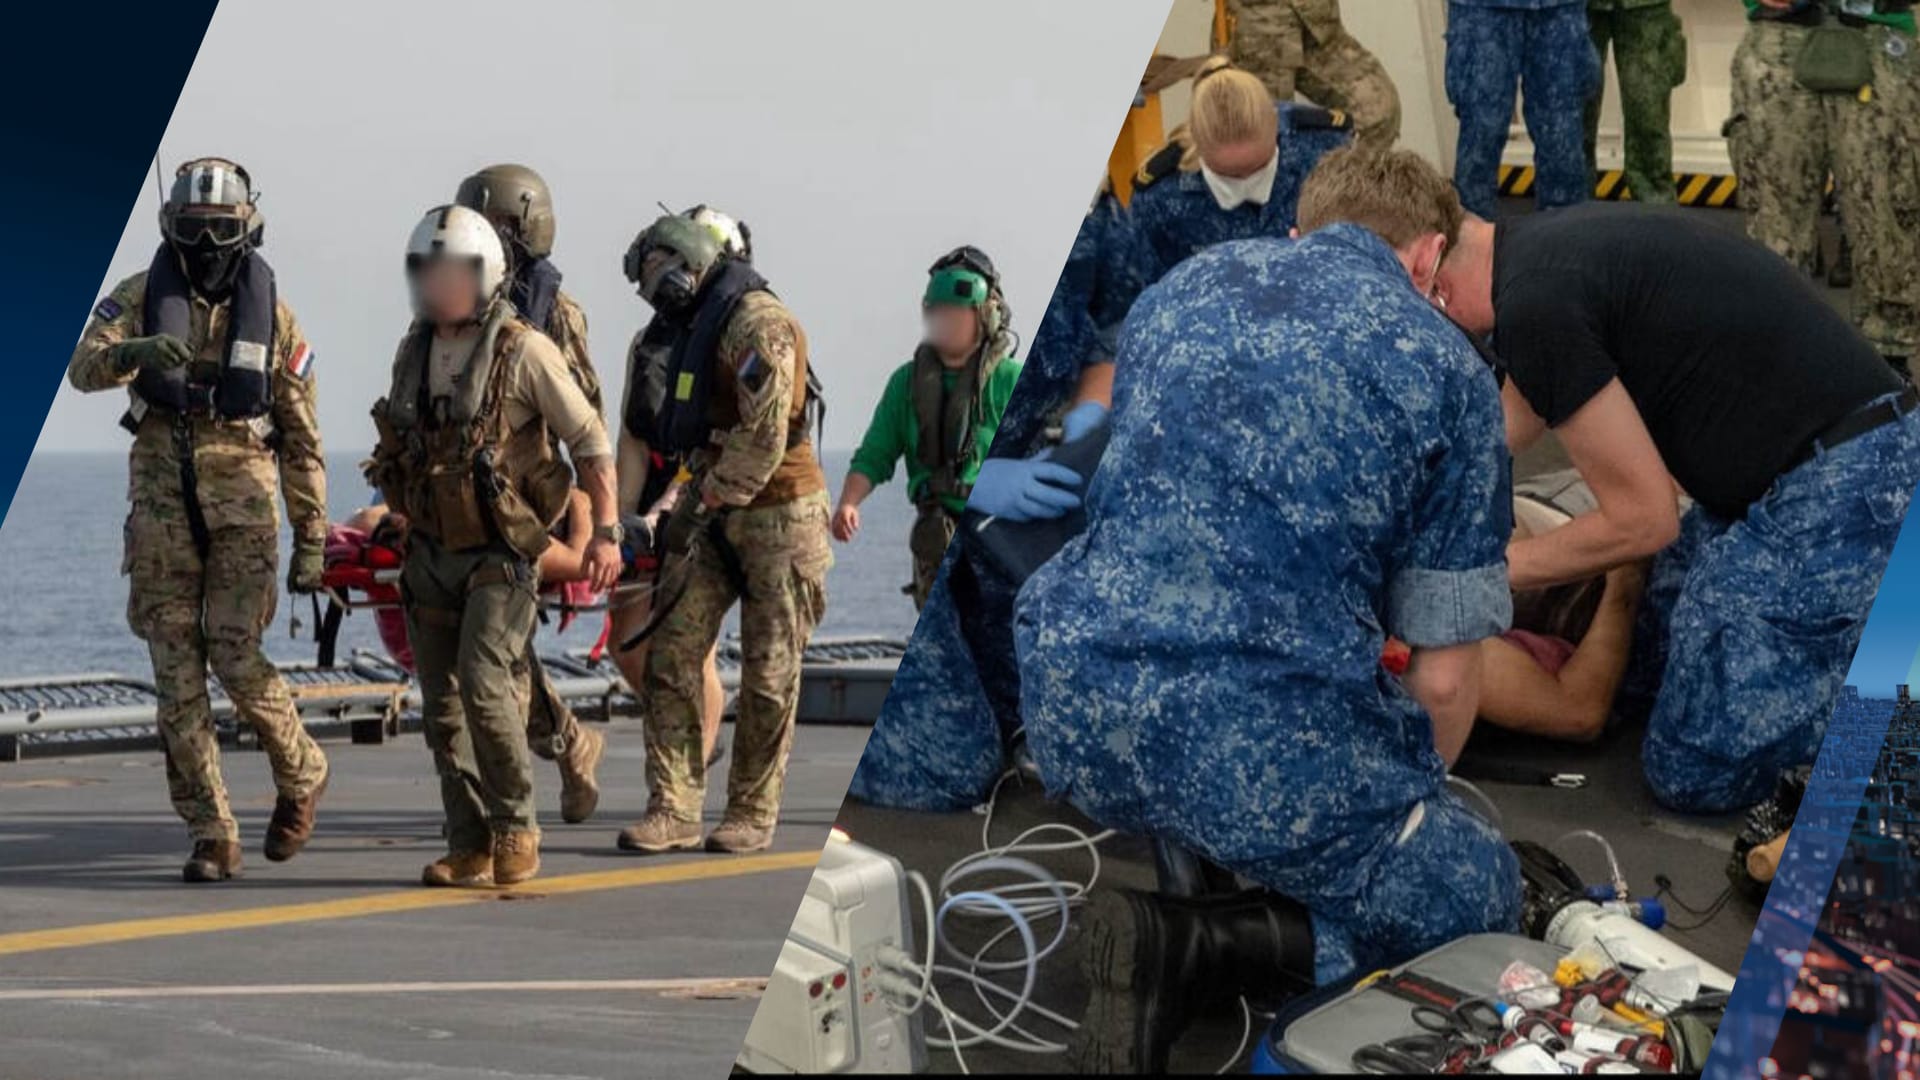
[1494,204,1901,519]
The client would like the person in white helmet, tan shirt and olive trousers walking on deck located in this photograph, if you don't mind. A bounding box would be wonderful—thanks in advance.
[367,206,620,888]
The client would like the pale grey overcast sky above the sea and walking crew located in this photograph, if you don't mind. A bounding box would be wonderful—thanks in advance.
[38,0,1167,452]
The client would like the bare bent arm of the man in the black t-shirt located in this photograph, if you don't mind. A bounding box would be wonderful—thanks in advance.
[1507,379,1680,588]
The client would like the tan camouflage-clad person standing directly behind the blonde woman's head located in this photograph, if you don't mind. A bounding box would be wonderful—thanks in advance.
[1227,0,1400,150]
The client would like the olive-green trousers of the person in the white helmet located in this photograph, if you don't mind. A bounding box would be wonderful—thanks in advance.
[399,532,536,851]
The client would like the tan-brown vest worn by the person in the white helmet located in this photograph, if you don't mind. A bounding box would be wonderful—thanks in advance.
[367,304,574,561]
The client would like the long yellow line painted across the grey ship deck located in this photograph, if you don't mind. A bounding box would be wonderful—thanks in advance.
[0,851,820,957]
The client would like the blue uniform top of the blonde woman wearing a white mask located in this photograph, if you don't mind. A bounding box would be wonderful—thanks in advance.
[1098,102,1354,327]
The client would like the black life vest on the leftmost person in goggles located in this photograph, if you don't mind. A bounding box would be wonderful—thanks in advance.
[132,244,275,419]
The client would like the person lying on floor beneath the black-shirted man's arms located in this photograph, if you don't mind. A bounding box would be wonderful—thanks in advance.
[1386,478,1647,742]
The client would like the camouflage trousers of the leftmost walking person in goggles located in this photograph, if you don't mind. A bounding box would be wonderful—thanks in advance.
[125,509,326,840]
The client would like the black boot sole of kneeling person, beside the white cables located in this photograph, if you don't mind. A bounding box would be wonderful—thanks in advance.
[1068,892,1173,1074]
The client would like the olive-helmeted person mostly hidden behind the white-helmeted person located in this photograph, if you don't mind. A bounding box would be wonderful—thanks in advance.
[453,165,607,822]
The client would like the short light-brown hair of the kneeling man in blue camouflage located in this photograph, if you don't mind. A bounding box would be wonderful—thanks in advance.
[1294,144,1465,252]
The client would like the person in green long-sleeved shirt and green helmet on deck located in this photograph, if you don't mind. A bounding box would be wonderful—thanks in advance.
[831,248,1020,611]
